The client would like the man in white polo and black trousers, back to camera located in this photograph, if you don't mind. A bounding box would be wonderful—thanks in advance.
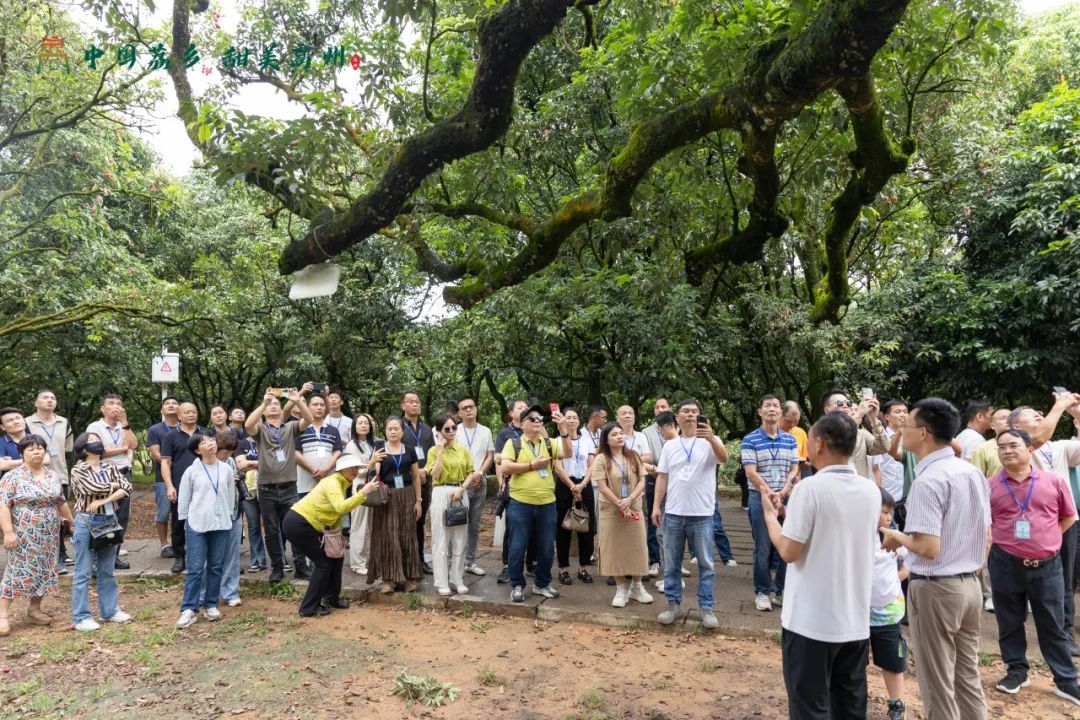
[752,412,881,720]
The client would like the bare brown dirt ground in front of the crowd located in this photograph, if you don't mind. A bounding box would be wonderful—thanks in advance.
[0,581,1080,720]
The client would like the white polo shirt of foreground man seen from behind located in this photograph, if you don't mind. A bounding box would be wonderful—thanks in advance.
[780,465,881,642]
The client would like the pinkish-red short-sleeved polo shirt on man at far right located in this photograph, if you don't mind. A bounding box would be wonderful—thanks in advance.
[989,467,1077,560]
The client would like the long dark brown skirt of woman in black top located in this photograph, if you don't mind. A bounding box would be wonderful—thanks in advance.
[367,487,423,585]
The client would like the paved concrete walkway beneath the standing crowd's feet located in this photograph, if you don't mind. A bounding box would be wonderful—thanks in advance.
[0,498,1038,655]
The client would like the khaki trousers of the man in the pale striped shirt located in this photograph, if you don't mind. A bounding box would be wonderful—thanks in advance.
[907,575,986,720]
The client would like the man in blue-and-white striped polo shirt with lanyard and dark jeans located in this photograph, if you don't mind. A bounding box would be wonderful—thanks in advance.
[742,395,799,612]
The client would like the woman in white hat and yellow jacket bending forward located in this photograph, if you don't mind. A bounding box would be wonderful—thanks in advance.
[282,456,379,617]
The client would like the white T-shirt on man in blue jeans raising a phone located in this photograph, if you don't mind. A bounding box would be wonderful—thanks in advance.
[657,437,717,517]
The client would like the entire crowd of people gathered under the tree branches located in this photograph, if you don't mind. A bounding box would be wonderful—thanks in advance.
[6,382,1080,720]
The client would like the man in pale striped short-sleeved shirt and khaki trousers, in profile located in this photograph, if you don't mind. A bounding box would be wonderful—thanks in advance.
[881,397,990,720]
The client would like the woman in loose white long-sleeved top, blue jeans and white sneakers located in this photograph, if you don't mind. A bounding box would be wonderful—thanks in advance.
[176,433,237,628]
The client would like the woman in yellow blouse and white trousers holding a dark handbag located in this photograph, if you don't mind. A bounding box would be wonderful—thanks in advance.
[424,415,484,597]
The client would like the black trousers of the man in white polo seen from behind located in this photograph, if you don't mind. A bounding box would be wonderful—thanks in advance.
[782,629,870,720]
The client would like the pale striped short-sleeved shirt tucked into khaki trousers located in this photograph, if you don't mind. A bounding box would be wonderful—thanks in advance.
[904,447,990,578]
